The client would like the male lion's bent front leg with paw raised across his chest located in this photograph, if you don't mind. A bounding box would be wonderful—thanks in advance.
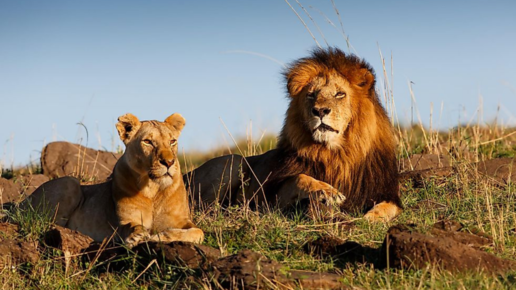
[277,174,346,208]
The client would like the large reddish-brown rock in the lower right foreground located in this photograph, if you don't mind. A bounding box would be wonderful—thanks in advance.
[382,226,516,273]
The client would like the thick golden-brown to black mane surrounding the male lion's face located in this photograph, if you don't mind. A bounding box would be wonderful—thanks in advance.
[267,48,401,211]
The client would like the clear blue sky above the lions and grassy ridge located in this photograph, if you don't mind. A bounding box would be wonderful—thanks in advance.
[0,0,516,167]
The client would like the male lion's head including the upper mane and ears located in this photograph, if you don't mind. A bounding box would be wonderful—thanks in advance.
[283,50,374,149]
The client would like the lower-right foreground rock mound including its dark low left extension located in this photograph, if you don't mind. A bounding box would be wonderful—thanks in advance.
[305,220,516,274]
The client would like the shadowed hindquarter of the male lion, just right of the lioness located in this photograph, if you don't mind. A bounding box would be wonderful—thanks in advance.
[183,155,243,204]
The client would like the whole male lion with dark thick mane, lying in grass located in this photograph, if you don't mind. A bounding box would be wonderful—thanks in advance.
[184,48,402,221]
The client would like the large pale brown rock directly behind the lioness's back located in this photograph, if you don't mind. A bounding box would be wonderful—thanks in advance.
[41,142,121,182]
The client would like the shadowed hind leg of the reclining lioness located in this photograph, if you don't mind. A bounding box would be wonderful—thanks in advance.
[21,177,83,226]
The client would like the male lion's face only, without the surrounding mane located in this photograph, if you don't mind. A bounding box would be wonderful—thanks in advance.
[300,72,355,148]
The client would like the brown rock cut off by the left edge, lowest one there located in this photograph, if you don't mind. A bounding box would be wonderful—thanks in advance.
[0,239,39,271]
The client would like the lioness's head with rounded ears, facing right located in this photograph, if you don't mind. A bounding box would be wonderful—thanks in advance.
[117,114,185,187]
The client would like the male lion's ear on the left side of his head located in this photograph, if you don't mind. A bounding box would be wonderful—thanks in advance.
[285,61,317,97]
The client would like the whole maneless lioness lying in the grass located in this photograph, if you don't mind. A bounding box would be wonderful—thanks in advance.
[26,114,204,247]
